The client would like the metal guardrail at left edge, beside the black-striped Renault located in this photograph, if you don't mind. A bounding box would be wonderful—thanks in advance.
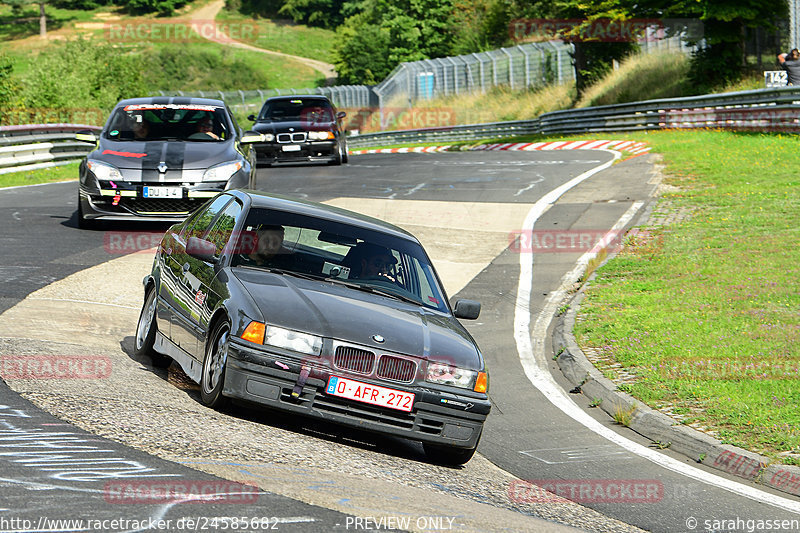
[0,124,101,174]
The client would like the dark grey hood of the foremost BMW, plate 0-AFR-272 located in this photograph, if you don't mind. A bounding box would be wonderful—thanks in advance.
[234,269,482,370]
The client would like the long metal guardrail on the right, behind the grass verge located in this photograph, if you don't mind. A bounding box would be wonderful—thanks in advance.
[348,87,800,149]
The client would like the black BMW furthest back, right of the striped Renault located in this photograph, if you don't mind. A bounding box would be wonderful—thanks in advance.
[248,95,348,166]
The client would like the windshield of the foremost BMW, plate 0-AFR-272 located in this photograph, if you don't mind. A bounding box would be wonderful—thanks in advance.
[231,209,447,312]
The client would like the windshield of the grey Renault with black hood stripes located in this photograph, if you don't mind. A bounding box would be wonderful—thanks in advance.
[103,104,231,142]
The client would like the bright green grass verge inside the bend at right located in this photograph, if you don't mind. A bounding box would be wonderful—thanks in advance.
[576,131,800,464]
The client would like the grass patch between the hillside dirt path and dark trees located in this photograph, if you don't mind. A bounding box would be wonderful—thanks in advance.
[217,10,336,62]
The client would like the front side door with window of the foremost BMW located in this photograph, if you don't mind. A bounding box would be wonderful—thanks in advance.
[160,194,232,353]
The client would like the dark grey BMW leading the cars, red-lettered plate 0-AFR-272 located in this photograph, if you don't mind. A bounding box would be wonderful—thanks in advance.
[135,190,491,464]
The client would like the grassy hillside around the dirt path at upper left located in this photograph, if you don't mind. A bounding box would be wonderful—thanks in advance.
[0,1,324,96]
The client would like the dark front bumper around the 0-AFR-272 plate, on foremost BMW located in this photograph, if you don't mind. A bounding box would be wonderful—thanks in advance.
[223,339,491,448]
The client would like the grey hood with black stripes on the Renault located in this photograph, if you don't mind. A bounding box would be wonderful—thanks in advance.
[94,140,236,170]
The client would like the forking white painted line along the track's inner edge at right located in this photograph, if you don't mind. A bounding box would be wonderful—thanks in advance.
[514,150,800,513]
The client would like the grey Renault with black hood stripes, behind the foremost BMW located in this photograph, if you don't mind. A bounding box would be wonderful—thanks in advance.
[76,97,261,227]
